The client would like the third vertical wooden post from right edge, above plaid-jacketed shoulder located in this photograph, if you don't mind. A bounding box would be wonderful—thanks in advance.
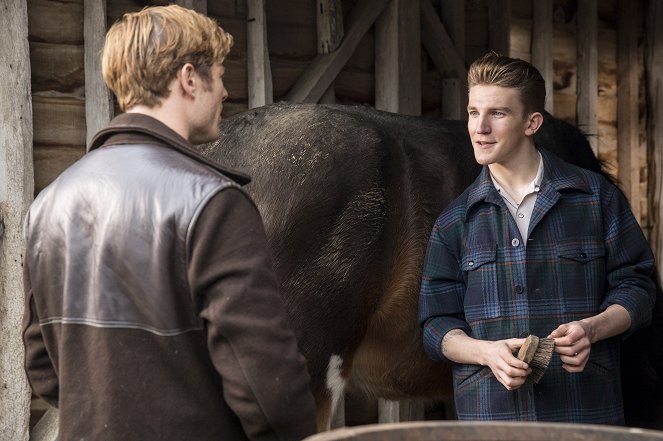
[577,0,598,155]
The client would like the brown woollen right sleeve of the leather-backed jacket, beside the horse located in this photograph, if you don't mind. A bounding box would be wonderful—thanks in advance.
[188,187,316,441]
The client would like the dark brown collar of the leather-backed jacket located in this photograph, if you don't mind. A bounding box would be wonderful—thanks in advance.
[88,113,251,185]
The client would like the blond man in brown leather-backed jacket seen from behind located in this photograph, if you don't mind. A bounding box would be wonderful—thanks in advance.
[24,6,315,441]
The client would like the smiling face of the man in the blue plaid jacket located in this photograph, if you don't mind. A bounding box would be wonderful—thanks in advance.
[467,85,531,165]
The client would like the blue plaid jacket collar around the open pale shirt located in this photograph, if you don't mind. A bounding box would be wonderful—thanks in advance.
[465,148,591,218]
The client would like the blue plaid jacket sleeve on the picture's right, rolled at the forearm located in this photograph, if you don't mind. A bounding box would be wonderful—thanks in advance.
[601,186,656,337]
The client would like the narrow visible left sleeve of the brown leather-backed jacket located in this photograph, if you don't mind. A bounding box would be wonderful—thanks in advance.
[23,249,59,407]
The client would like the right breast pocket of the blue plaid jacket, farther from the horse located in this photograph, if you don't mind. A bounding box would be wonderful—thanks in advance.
[557,237,605,312]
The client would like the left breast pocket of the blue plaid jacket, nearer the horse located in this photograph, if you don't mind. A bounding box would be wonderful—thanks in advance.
[462,245,500,323]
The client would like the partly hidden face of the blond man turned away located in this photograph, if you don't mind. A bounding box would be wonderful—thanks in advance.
[189,63,228,144]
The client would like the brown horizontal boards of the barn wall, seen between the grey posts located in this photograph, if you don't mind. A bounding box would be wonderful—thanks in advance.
[27,0,648,226]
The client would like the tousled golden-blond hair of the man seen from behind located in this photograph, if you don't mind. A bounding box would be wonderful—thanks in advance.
[101,5,233,111]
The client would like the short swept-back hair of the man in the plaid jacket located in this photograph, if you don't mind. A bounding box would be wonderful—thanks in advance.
[467,52,546,113]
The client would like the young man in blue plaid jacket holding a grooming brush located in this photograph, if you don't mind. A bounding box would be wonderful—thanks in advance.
[419,53,655,424]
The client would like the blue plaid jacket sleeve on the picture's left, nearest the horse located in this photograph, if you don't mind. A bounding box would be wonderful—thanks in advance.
[419,223,471,361]
